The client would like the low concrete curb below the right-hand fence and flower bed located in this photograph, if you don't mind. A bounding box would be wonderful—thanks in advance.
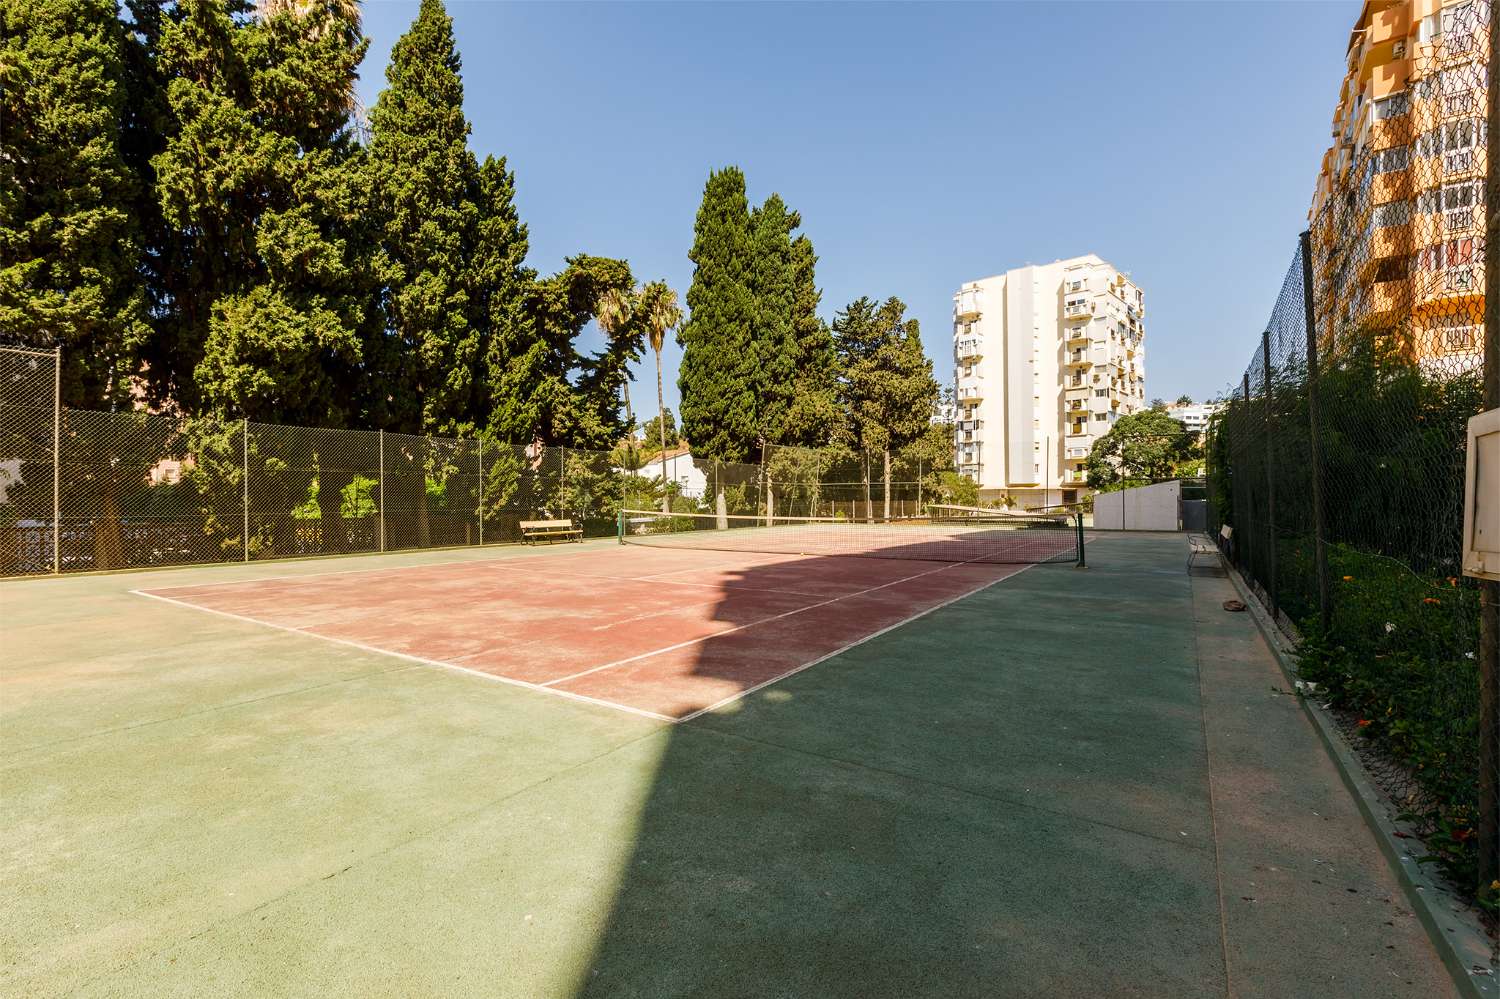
[1224,560,1500,999]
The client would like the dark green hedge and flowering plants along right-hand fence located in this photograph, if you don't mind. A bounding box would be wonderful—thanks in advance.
[1208,244,1497,896]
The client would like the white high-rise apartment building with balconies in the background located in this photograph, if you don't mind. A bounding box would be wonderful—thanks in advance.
[953,254,1146,507]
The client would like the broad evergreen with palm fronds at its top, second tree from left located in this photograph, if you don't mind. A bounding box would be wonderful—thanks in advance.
[153,0,368,420]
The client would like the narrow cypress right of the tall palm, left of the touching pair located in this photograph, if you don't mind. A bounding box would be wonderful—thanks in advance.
[677,167,759,518]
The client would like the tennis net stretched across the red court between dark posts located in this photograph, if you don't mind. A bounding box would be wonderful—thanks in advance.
[620,510,1083,564]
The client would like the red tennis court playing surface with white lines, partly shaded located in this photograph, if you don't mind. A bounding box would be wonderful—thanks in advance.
[138,546,1026,722]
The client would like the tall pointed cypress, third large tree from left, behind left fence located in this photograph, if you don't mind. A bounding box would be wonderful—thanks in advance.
[369,0,480,437]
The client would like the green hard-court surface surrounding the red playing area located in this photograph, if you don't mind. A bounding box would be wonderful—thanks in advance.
[0,536,1454,998]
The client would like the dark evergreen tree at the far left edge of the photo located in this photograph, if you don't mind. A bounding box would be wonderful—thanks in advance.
[0,0,149,408]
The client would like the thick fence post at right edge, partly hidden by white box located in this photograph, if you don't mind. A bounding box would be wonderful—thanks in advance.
[1479,0,1500,900]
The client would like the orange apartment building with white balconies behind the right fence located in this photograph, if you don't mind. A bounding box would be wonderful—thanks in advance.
[1308,0,1490,371]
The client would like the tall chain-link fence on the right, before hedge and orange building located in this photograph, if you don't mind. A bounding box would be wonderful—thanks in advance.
[1209,3,1500,897]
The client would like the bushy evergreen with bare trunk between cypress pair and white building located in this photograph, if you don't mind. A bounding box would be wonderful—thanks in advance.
[833,297,939,516]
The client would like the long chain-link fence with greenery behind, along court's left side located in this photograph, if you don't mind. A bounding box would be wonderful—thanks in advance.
[0,348,932,576]
